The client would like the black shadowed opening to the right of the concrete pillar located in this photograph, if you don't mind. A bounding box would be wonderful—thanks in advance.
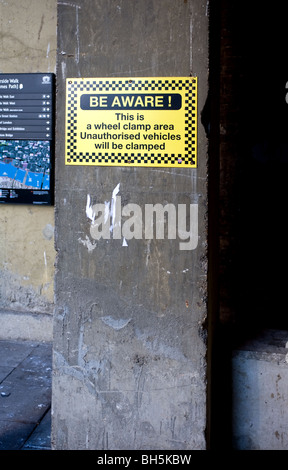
[211,0,288,450]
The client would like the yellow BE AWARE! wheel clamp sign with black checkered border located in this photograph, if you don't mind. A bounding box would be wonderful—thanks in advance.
[65,77,197,168]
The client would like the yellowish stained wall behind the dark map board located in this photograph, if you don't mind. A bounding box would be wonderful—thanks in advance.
[0,0,57,340]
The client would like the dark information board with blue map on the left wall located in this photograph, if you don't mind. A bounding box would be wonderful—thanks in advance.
[0,73,55,205]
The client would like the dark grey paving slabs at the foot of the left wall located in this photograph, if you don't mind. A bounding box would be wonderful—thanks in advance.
[0,340,52,450]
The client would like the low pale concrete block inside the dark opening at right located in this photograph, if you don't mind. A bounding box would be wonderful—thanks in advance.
[232,330,288,450]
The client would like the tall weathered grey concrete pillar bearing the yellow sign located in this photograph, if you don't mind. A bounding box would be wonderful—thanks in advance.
[52,0,208,450]
